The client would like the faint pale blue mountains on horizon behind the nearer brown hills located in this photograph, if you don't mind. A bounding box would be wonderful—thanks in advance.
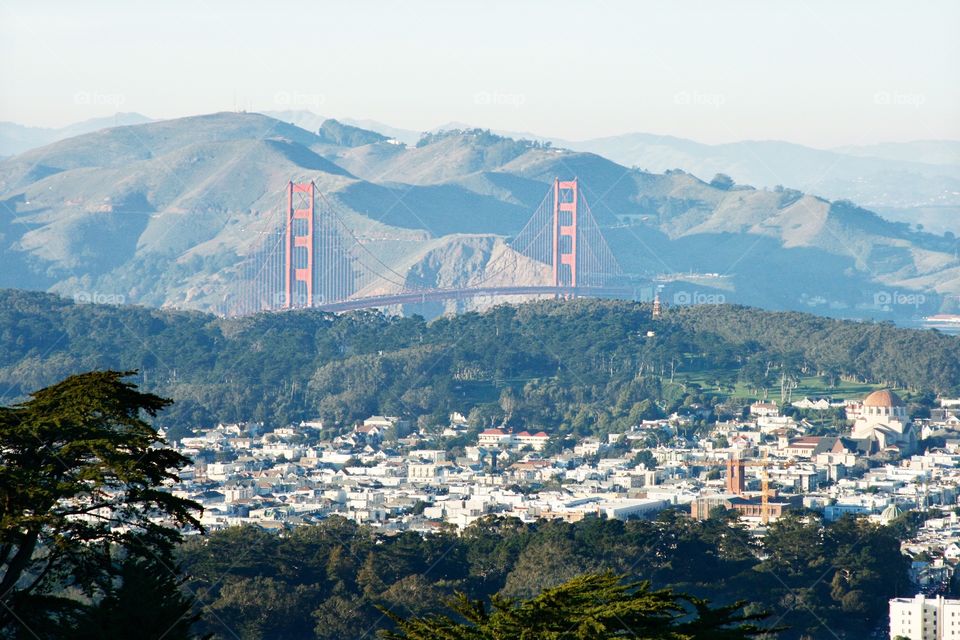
[9,109,960,233]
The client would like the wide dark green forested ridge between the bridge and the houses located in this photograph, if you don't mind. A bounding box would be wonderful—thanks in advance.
[0,290,960,434]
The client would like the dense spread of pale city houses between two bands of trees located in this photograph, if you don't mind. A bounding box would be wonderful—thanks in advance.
[163,391,960,552]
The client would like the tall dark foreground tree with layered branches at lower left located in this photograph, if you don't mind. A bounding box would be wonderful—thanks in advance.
[0,371,199,638]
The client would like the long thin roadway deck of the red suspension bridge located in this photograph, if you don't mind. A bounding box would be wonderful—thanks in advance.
[314,285,637,311]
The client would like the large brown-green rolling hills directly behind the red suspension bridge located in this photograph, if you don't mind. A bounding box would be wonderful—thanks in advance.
[0,113,960,319]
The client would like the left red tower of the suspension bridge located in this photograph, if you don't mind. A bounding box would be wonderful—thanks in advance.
[283,182,316,309]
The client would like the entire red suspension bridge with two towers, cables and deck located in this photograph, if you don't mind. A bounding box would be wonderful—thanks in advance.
[222,178,633,315]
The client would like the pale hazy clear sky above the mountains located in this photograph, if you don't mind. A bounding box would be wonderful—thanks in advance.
[0,0,960,147]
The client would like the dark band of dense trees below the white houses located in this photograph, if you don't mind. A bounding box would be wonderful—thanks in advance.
[180,512,909,640]
